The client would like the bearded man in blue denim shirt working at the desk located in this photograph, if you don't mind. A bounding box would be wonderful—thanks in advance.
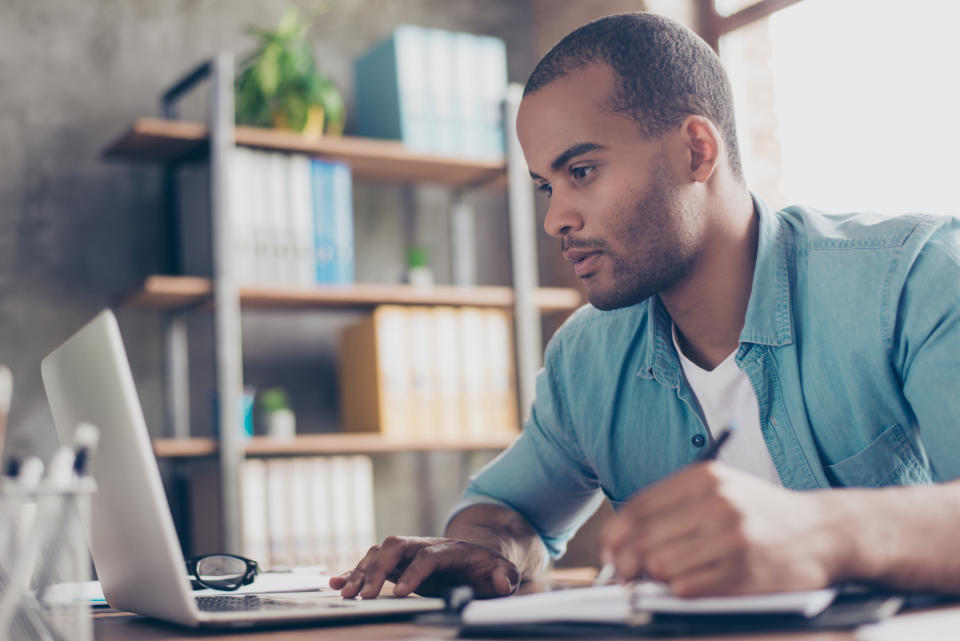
[331,14,960,597]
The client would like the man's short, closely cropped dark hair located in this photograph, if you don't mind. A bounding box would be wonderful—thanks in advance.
[523,13,743,182]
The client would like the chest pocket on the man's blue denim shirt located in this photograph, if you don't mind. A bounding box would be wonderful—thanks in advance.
[824,424,933,487]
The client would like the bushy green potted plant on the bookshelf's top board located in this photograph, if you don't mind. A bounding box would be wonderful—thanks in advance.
[236,7,346,137]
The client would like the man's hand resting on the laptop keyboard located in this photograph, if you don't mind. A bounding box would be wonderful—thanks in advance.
[330,536,520,599]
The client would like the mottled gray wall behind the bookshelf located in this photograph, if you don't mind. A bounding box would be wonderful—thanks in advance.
[0,0,533,544]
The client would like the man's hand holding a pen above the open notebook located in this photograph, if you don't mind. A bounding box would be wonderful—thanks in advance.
[602,462,851,596]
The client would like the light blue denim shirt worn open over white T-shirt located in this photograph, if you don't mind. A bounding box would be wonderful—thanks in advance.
[453,198,960,556]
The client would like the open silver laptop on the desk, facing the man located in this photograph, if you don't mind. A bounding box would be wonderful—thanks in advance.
[41,310,444,627]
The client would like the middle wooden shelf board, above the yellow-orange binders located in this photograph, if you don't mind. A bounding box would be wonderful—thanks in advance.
[121,276,583,312]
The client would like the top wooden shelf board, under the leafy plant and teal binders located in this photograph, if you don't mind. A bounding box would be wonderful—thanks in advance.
[103,118,506,187]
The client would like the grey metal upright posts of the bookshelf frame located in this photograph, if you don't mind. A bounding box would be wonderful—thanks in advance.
[150,51,542,553]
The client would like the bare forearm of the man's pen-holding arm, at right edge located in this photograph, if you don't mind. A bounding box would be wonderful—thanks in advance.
[825,481,960,593]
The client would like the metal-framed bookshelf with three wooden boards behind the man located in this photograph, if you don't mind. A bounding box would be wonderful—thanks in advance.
[103,52,564,551]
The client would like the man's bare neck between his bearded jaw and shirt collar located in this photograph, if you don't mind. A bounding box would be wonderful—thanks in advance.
[660,189,759,370]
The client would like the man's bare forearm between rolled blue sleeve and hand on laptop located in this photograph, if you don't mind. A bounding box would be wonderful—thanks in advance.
[444,504,544,579]
